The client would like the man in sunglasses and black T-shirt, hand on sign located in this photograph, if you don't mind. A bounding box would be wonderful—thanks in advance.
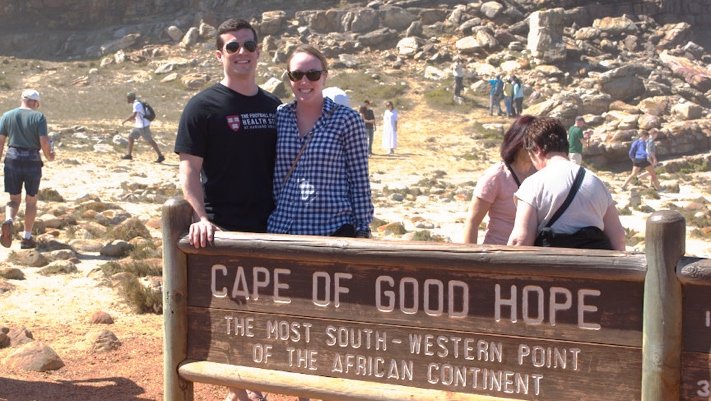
[175,19,281,401]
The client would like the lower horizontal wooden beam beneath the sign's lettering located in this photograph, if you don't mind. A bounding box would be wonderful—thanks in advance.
[178,361,516,401]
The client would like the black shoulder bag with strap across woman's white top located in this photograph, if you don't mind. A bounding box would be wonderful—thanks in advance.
[533,167,612,249]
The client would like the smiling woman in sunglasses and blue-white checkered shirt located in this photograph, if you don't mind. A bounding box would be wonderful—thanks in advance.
[267,45,373,237]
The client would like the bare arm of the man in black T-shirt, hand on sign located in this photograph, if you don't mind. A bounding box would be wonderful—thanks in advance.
[178,153,219,248]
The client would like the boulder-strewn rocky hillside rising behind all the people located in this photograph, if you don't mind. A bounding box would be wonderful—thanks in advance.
[0,0,711,165]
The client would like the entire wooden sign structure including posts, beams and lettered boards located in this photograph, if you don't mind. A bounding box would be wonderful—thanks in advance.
[163,199,711,401]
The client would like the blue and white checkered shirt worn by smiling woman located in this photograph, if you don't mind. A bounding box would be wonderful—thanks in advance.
[267,98,373,235]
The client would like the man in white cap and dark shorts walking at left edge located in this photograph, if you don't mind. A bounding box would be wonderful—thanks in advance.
[0,89,54,249]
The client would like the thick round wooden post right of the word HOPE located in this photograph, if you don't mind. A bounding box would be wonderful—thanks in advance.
[642,210,686,401]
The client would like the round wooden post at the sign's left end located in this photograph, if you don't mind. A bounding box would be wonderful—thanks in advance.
[162,198,193,401]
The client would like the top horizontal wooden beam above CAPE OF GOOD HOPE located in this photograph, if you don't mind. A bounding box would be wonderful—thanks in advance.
[178,232,647,282]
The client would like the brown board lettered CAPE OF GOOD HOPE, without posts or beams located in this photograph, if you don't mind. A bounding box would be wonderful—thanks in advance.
[182,252,643,401]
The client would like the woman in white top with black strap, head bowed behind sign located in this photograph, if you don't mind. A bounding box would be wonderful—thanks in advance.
[508,117,625,251]
